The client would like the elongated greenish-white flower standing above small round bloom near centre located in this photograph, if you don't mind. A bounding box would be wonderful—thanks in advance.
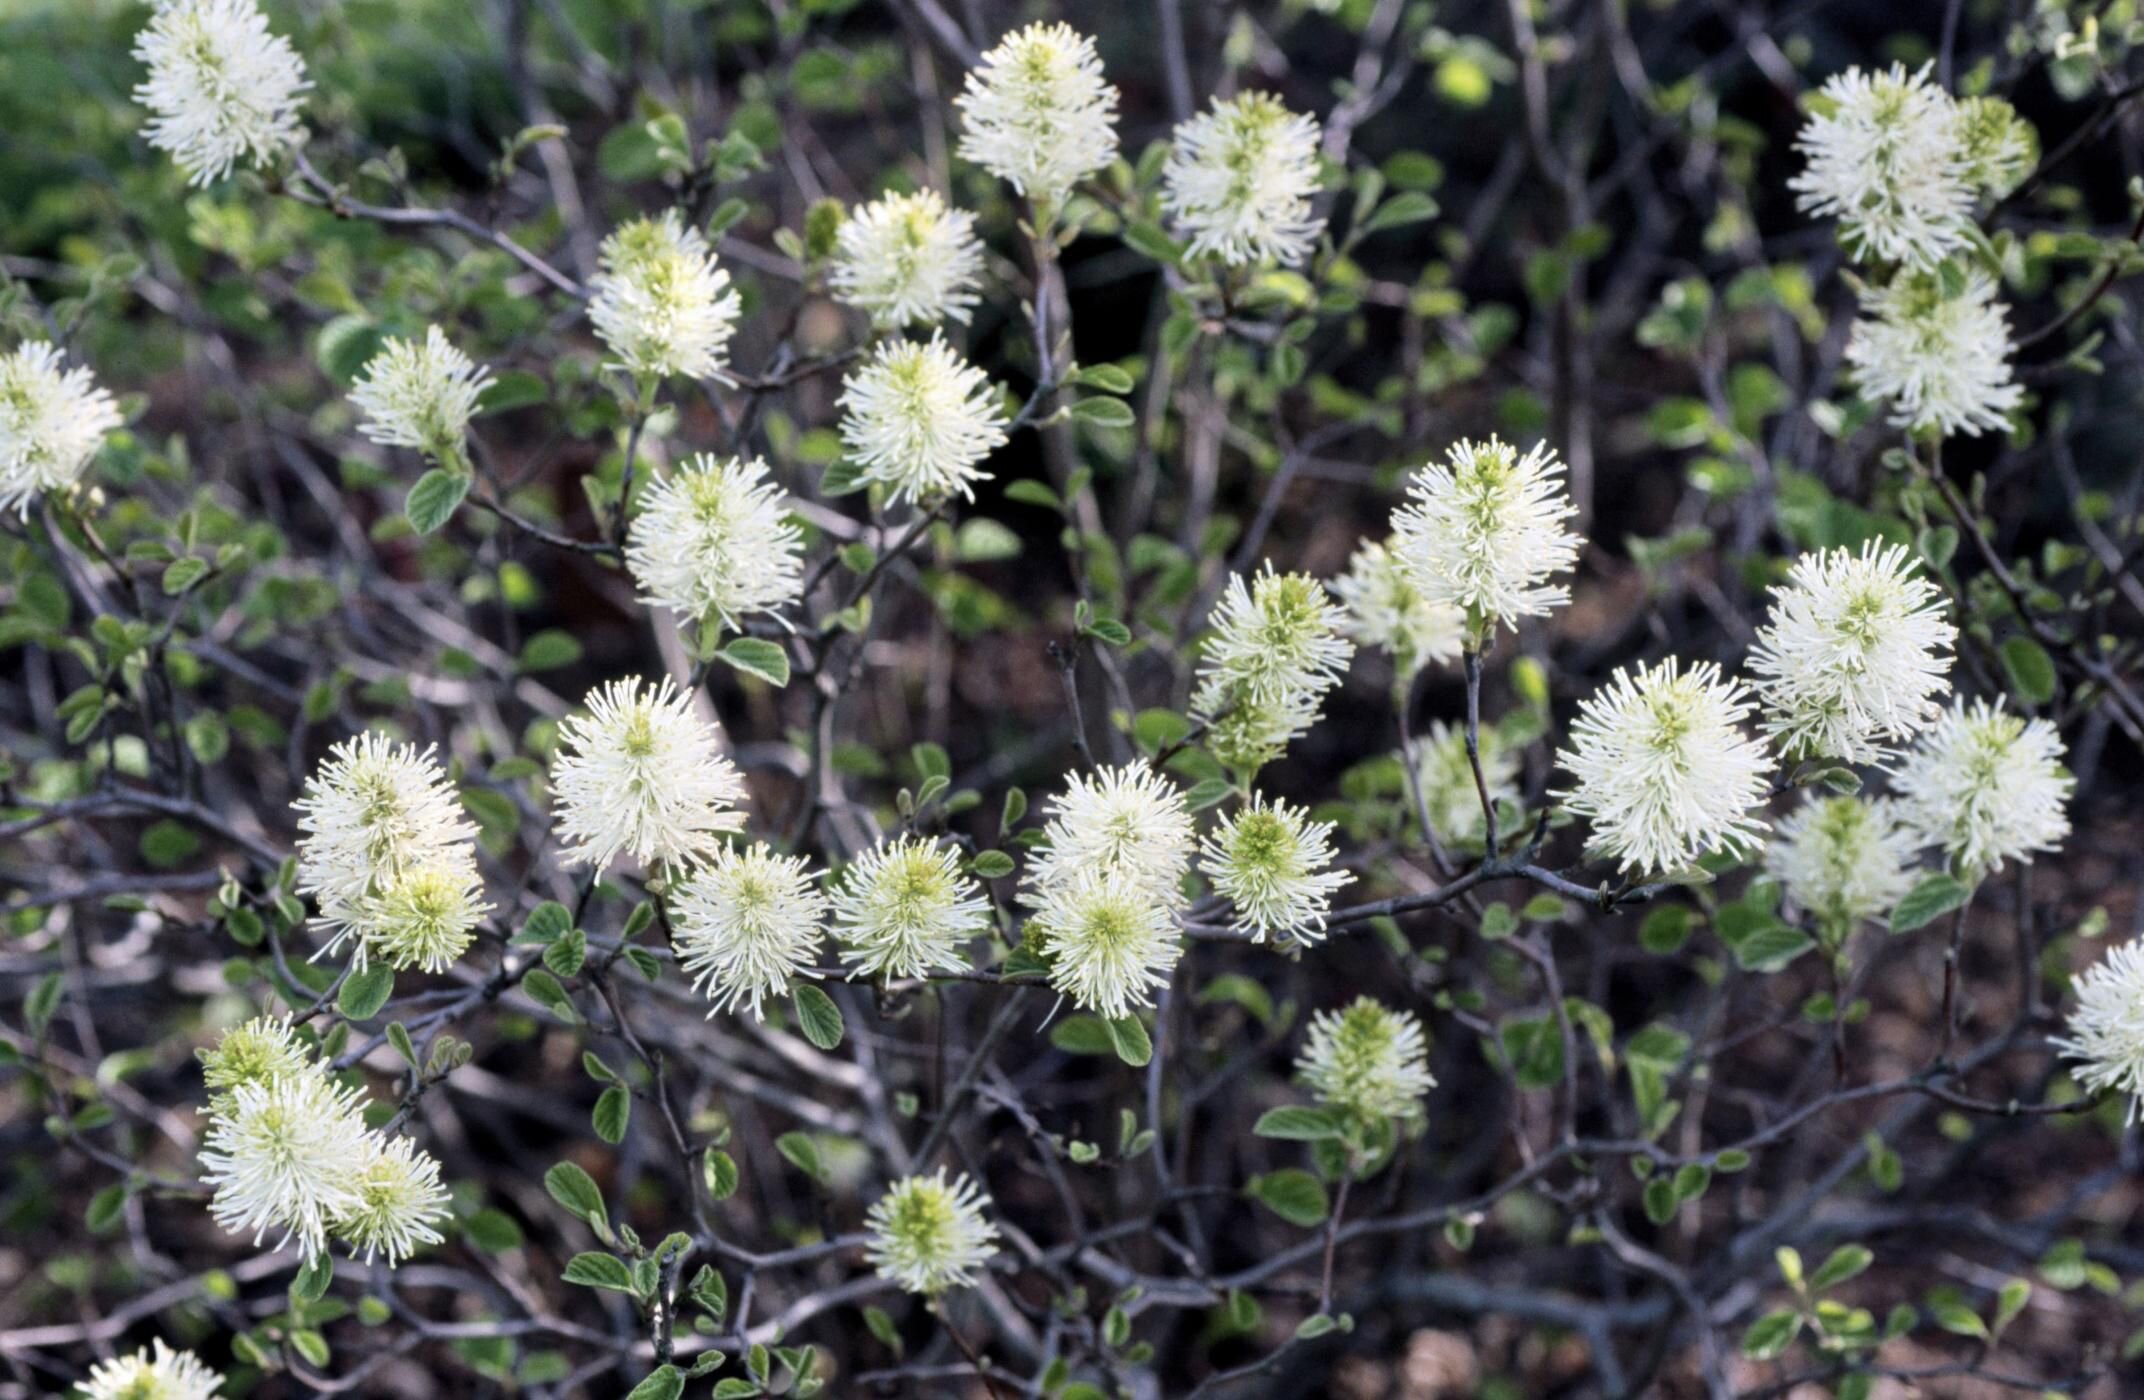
[1190,564,1355,770]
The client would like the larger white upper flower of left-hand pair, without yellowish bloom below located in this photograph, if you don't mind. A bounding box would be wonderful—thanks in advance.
[292,731,480,958]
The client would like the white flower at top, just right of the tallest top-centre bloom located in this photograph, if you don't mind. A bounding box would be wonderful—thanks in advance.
[1162,92,1325,268]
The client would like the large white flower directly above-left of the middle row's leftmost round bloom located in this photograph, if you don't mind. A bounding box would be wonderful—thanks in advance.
[551,675,744,870]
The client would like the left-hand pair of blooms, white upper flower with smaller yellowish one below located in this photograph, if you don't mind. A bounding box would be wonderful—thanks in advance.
[292,731,491,973]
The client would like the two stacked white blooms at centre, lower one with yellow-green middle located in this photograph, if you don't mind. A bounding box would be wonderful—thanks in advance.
[1021,761,1192,1018]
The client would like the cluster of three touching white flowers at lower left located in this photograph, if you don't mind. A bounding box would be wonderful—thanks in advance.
[202,1016,448,1267]
